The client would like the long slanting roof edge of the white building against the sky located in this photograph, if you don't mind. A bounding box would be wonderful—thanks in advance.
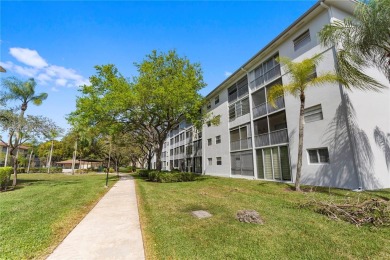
[205,0,338,99]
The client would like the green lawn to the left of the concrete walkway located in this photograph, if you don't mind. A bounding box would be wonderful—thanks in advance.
[0,173,117,259]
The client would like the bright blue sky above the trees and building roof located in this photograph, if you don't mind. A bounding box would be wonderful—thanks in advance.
[0,0,316,134]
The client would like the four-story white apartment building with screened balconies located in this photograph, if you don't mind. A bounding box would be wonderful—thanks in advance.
[152,0,390,189]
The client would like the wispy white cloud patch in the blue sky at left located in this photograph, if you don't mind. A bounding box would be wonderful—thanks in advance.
[0,48,89,91]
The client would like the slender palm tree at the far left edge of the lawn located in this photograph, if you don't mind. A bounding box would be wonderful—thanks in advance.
[2,77,47,186]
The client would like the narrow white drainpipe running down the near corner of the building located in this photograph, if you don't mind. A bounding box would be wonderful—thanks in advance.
[320,1,363,191]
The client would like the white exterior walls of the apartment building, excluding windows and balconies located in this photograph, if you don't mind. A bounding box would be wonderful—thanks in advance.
[147,1,390,189]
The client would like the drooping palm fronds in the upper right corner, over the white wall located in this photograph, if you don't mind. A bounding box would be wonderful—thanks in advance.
[319,0,390,91]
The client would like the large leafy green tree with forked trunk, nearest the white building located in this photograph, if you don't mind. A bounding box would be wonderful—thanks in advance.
[134,51,206,170]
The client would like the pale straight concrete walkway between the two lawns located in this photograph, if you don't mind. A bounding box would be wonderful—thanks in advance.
[47,177,145,260]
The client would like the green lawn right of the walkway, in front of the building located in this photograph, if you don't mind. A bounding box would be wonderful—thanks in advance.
[136,177,390,259]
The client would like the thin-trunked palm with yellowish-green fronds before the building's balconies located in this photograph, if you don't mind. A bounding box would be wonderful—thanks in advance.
[267,55,340,191]
